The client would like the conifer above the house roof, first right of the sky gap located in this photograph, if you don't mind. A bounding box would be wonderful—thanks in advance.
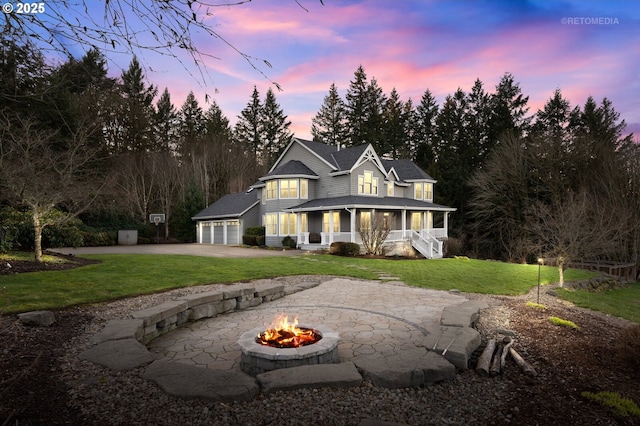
[311,83,348,146]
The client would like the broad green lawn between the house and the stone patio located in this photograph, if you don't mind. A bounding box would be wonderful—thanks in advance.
[0,254,624,322]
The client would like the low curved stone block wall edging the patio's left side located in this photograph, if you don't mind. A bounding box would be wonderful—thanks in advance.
[131,284,285,344]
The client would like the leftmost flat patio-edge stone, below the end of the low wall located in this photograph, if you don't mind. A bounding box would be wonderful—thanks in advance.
[80,339,155,370]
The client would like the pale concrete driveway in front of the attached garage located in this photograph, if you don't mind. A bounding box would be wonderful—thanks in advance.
[49,244,302,257]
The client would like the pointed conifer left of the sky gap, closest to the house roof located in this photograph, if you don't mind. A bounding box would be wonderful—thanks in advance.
[262,88,293,164]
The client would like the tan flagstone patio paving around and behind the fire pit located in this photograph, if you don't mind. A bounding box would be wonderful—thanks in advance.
[148,278,467,371]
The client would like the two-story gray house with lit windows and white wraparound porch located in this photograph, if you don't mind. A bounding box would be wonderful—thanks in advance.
[193,138,455,258]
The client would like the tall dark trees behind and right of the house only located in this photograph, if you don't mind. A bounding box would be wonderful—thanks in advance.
[311,66,640,268]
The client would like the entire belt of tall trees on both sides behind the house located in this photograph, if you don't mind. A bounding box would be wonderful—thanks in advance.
[0,35,640,262]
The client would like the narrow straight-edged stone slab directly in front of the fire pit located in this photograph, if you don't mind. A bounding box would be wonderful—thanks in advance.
[256,362,362,395]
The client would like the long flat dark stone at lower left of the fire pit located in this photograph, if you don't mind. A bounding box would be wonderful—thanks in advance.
[143,361,260,402]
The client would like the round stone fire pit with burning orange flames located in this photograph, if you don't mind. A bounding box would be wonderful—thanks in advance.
[238,316,340,376]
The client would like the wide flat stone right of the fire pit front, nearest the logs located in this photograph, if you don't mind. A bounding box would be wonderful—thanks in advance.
[354,348,456,389]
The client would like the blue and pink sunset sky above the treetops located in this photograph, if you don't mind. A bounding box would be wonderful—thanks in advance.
[46,0,640,138]
